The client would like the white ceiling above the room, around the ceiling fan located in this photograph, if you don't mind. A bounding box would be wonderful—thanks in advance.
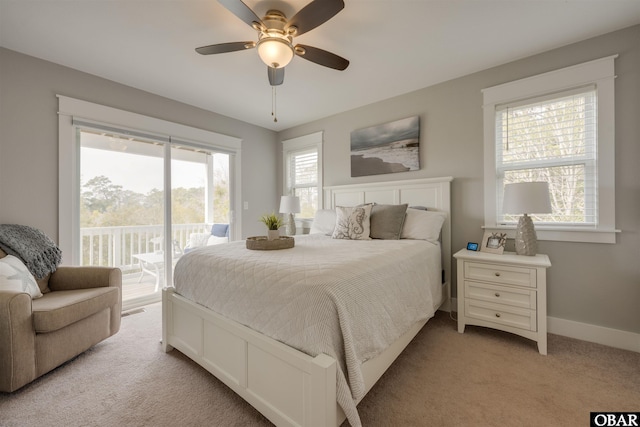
[0,0,640,130]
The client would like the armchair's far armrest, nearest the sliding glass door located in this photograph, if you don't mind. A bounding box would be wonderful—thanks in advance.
[49,266,122,293]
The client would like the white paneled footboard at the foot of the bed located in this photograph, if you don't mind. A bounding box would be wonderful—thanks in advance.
[162,288,343,426]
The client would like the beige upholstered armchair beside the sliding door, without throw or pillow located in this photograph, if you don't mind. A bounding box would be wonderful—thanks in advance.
[0,250,122,392]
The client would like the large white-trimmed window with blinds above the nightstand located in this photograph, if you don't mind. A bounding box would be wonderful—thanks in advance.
[483,56,616,243]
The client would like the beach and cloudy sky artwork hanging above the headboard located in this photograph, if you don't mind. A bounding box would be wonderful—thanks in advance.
[351,116,420,177]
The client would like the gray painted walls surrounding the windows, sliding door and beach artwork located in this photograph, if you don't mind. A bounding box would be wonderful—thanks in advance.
[0,26,640,333]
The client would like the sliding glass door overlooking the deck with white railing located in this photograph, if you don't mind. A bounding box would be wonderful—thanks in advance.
[77,127,233,309]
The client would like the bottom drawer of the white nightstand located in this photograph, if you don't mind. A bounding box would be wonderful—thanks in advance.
[465,300,537,331]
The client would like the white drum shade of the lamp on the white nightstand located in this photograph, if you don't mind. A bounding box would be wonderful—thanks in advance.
[502,182,552,214]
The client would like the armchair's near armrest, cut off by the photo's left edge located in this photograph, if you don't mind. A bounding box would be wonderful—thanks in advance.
[0,291,36,392]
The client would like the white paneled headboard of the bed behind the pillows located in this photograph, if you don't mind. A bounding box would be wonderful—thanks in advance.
[324,176,453,311]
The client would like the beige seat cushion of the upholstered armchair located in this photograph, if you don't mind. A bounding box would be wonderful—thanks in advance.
[32,287,120,333]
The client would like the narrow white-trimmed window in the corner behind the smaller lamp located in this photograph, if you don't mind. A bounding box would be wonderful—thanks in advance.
[282,132,322,220]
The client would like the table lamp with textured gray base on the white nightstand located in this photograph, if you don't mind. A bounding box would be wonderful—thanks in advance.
[502,182,552,256]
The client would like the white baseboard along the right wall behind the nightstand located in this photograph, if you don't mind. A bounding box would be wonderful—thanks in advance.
[451,298,640,353]
